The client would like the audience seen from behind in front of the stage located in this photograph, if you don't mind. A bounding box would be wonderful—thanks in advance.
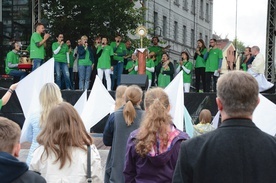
[0,69,276,183]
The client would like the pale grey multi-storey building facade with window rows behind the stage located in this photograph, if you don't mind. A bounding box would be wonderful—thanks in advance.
[143,0,213,61]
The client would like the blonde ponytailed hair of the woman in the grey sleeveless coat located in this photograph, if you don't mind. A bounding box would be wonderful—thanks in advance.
[123,85,143,126]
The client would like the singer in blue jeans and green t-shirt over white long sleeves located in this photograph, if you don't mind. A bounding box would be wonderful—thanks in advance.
[52,34,71,90]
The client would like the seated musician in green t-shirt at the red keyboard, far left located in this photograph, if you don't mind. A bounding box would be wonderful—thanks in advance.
[5,42,27,80]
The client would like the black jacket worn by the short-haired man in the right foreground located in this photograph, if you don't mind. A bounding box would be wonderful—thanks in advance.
[173,119,276,183]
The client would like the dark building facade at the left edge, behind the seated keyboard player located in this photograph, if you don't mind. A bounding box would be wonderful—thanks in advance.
[0,0,32,74]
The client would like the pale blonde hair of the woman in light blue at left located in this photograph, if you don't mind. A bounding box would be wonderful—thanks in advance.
[39,83,63,127]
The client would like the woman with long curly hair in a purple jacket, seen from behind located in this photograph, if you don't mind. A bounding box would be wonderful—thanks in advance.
[124,88,189,183]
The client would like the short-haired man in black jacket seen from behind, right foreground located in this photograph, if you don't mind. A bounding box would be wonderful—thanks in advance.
[173,71,276,183]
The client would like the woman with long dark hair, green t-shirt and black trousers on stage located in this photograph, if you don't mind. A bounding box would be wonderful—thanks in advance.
[194,39,207,92]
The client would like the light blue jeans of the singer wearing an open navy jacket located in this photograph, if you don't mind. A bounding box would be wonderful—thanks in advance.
[78,65,92,90]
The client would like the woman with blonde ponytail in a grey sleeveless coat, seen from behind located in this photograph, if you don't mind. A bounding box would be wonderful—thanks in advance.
[103,85,144,183]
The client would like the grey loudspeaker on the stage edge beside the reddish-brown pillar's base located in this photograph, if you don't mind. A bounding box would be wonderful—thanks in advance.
[121,74,148,90]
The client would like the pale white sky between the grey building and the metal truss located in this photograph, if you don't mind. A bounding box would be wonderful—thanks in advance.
[213,0,268,54]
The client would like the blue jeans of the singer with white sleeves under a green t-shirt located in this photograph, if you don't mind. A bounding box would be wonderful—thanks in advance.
[55,62,71,89]
